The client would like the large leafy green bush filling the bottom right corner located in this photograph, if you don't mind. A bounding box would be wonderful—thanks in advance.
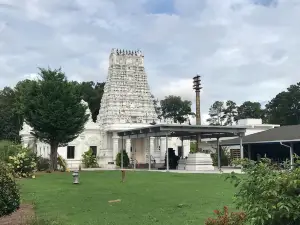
[228,158,300,225]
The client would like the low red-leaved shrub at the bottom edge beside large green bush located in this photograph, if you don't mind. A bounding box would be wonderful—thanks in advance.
[205,206,246,225]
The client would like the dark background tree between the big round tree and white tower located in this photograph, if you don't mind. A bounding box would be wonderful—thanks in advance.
[80,81,105,122]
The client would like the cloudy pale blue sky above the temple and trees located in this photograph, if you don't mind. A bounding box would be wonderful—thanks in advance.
[0,0,300,125]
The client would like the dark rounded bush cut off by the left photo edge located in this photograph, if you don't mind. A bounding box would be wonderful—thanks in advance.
[0,161,20,217]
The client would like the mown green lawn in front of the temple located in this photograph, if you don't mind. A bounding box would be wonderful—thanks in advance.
[20,171,234,225]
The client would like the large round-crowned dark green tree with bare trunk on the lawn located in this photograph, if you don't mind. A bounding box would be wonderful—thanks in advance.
[22,68,89,171]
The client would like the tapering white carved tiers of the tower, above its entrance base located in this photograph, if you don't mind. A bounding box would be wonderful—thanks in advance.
[98,49,157,127]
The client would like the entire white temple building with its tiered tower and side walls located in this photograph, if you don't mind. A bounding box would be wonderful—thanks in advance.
[20,49,190,168]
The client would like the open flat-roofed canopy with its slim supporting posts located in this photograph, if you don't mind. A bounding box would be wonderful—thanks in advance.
[117,124,246,171]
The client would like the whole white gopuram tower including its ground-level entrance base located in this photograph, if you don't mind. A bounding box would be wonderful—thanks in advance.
[97,49,157,164]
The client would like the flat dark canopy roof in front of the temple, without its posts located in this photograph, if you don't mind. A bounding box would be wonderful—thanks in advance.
[118,124,246,139]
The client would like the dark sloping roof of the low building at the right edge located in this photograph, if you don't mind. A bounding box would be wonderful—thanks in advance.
[220,125,300,146]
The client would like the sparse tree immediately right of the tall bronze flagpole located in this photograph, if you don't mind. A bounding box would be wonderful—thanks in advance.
[206,101,225,126]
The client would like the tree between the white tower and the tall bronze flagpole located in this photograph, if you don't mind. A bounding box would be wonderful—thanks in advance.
[160,95,195,124]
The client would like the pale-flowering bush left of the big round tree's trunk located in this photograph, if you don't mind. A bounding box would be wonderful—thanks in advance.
[8,147,37,177]
